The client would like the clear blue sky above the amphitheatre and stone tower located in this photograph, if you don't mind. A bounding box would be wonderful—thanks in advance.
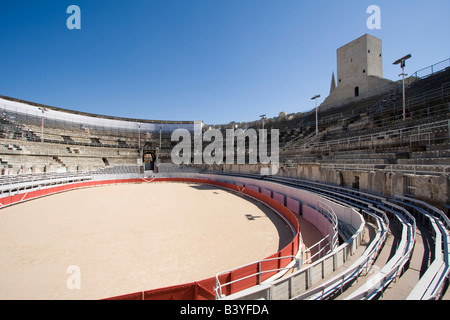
[0,0,450,124]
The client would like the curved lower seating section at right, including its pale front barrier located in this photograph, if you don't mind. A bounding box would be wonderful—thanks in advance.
[205,172,450,300]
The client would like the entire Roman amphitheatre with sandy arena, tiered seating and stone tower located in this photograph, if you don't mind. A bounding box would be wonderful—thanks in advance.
[0,35,450,300]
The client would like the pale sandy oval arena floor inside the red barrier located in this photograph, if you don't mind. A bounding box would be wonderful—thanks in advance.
[0,183,320,299]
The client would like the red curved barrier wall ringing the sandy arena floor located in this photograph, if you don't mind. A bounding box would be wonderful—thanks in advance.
[0,178,301,300]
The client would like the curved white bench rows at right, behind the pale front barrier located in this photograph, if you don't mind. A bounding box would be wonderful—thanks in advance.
[206,172,450,300]
